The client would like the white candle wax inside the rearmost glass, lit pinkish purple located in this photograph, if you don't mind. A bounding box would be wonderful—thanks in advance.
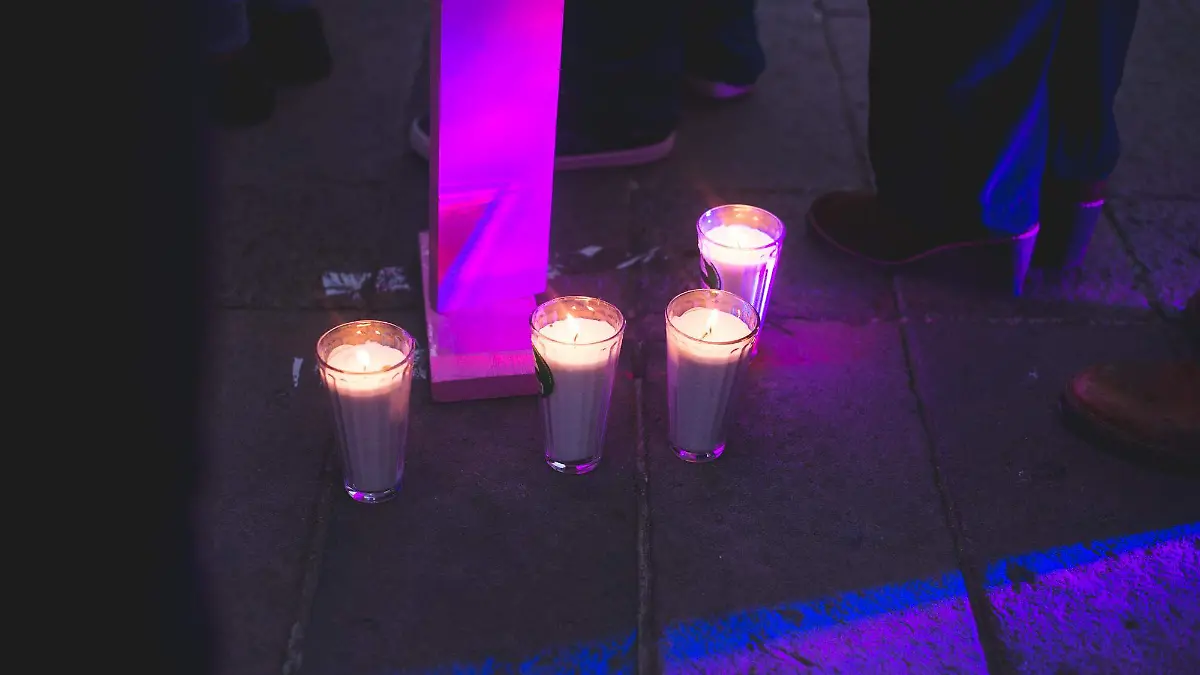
[700,223,779,319]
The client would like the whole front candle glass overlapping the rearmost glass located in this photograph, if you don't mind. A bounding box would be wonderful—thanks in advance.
[666,289,760,462]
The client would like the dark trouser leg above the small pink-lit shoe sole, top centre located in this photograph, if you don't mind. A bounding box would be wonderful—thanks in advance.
[683,0,767,98]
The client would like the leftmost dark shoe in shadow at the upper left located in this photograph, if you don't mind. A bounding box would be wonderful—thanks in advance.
[209,47,275,127]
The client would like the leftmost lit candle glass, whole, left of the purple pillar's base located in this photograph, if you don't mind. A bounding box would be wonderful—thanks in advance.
[317,321,416,503]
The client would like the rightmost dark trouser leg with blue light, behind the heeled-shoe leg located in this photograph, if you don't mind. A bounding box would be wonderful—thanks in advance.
[1037,0,1138,268]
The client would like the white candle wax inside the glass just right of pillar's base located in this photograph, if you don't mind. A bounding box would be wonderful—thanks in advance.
[536,317,620,464]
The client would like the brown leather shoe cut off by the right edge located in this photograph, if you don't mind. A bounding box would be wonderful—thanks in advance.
[1062,362,1200,470]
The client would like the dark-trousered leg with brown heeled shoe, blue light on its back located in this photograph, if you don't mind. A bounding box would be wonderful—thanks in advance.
[809,0,1064,289]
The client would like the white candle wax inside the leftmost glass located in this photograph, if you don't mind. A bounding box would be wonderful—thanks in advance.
[325,342,412,492]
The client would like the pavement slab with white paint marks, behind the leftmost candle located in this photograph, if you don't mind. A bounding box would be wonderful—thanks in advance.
[214,176,428,309]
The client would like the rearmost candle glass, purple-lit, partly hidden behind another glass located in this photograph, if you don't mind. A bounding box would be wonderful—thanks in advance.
[696,204,787,321]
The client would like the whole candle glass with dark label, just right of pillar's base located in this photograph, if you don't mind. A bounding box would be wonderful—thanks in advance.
[529,295,625,473]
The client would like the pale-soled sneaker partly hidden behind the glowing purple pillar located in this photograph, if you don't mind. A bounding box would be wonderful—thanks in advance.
[408,114,676,171]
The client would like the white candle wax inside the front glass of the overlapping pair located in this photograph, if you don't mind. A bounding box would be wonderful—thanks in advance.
[667,307,750,453]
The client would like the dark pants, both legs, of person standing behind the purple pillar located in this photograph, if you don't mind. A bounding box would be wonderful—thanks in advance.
[559,0,766,138]
